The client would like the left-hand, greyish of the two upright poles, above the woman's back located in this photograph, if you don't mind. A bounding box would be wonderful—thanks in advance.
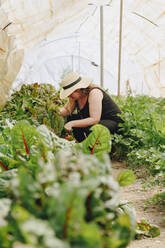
[100,6,104,87]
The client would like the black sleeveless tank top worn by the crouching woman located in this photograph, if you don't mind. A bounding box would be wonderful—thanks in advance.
[76,87,123,123]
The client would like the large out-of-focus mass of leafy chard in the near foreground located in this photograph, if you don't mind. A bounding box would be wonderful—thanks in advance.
[0,144,135,248]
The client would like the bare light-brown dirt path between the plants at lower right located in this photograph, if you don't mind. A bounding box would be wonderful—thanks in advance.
[112,162,165,248]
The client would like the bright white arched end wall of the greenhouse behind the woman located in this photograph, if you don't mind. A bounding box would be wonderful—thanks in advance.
[13,34,146,94]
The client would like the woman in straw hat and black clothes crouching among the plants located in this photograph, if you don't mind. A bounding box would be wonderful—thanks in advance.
[60,72,123,142]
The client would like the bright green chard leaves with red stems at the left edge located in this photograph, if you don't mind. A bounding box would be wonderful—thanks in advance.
[0,120,47,170]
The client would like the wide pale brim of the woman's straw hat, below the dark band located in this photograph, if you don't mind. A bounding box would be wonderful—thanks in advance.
[60,78,93,99]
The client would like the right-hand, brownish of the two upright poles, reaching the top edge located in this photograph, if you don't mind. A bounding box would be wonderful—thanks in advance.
[117,0,123,97]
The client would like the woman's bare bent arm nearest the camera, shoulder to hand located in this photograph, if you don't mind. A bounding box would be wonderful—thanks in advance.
[65,89,103,131]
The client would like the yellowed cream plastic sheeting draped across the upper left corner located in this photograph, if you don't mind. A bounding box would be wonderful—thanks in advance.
[0,0,91,105]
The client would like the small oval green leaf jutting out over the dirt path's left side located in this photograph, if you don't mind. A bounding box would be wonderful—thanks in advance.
[117,170,136,186]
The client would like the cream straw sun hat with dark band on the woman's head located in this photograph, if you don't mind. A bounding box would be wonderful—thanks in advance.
[60,72,93,99]
